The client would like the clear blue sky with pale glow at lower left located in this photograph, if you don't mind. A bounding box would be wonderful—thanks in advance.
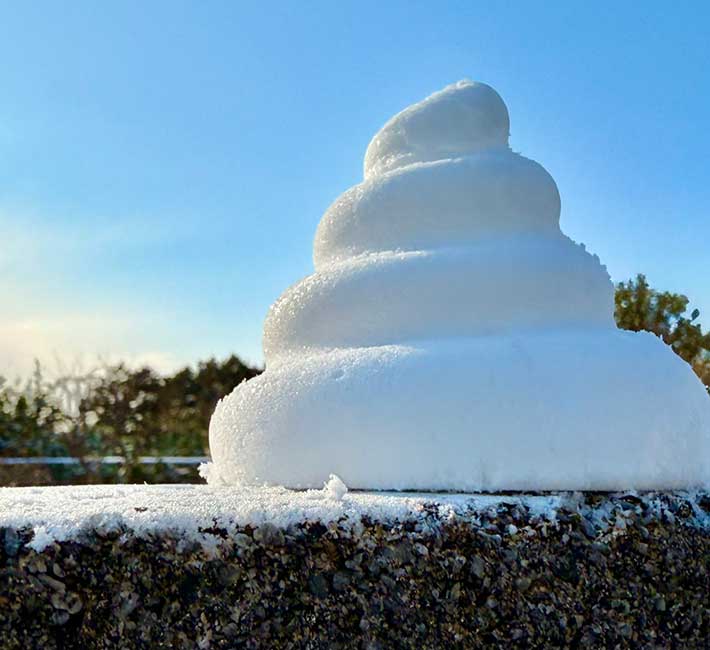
[0,1,710,374]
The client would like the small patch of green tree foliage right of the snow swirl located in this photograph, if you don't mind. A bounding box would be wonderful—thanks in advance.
[614,274,710,392]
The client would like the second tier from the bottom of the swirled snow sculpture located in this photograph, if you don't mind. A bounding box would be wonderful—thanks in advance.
[264,234,614,354]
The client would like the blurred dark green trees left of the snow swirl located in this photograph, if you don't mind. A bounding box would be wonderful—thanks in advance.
[0,356,260,484]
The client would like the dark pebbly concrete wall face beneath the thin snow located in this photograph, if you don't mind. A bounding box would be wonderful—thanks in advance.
[0,495,710,650]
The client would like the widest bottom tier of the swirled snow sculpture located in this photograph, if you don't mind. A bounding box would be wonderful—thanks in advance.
[211,328,708,491]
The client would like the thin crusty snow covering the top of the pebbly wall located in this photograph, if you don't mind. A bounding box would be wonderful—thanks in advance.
[0,476,710,552]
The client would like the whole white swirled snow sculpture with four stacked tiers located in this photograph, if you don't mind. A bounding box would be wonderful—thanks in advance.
[208,81,710,491]
